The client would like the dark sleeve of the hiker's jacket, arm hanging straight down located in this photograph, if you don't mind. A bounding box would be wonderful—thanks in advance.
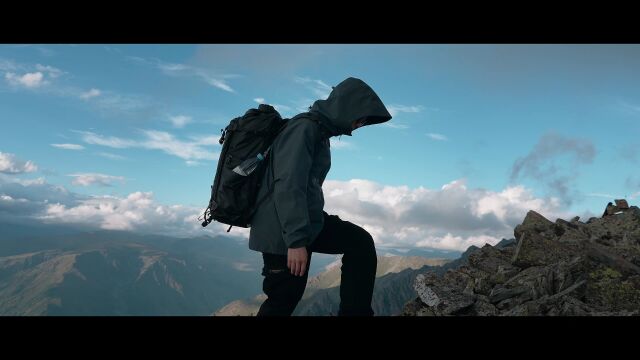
[273,119,318,248]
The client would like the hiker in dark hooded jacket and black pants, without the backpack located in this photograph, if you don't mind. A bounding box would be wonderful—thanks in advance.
[249,77,391,316]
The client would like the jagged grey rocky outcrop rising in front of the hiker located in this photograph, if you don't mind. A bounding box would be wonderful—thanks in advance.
[403,201,640,316]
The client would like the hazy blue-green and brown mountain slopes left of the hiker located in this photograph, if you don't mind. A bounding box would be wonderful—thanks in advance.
[0,231,261,315]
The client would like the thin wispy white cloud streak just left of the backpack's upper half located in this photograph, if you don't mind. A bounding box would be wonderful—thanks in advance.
[76,130,219,160]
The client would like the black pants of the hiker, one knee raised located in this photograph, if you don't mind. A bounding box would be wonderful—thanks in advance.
[257,212,378,316]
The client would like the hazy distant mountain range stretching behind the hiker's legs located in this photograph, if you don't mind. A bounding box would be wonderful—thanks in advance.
[0,219,476,315]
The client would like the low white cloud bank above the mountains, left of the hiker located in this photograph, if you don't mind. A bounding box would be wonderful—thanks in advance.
[0,174,242,238]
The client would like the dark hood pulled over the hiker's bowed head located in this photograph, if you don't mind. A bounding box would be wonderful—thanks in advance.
[310,77,391,136]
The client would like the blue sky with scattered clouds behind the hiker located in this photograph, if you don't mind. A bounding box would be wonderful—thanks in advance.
[0,44,640,250]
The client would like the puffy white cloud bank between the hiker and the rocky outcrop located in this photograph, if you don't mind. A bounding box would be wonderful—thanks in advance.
[323,179,569,250]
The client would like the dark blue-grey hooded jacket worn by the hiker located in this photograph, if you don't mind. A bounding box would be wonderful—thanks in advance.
[249,78,391,254]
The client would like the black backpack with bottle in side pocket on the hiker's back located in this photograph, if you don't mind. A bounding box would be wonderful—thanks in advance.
[202,104,287,232]
